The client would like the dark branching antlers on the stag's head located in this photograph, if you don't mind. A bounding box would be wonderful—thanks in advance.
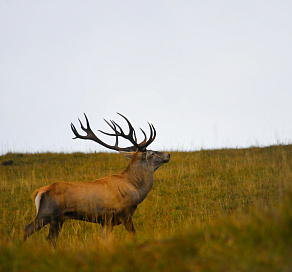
[71,113,156,151]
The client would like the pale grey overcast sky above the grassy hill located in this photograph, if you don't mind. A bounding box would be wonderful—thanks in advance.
[0,0,292,154]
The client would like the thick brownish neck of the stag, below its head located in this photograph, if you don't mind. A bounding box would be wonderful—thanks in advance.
[122,161,154,202]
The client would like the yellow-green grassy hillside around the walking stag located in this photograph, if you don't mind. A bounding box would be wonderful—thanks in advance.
[0,145,292,272]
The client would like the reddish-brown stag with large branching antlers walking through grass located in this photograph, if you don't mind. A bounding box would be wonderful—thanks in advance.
[23,113,170,247]
